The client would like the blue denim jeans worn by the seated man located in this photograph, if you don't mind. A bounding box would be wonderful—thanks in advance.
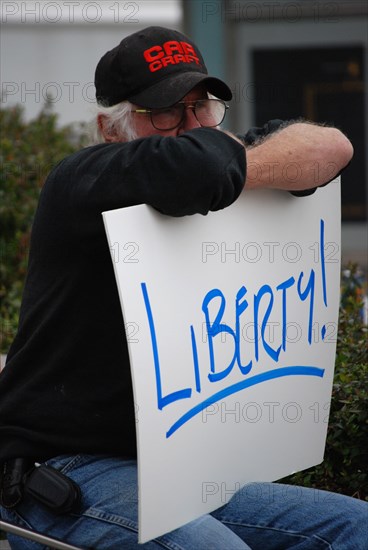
[0,455,368,550]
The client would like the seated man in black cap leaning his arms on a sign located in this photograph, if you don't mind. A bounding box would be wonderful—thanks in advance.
[0,27,368,550]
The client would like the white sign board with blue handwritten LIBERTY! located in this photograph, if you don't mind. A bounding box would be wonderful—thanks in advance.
[104,181,340,542]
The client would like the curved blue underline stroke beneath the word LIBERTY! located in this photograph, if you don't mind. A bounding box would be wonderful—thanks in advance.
[166,365,325,439]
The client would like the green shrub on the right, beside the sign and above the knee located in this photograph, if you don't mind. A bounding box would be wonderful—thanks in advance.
[282,265,368,500]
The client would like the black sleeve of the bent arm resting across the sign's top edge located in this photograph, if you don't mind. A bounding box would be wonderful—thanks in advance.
[40,128,246,247]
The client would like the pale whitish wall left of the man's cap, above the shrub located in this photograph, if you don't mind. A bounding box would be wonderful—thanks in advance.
[0,0,182,124]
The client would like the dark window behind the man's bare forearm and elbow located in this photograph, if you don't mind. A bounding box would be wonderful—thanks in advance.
[253,46,366,221]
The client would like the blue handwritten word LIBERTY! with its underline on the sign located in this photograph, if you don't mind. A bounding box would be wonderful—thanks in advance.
[141,220,327,438]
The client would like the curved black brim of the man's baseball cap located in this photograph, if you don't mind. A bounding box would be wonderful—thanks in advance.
[128,71,233,109]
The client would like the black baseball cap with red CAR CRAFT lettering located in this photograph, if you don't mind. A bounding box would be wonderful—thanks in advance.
[95,27,232,108]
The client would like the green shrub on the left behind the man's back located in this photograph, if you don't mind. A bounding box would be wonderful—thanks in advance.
[0,105,83,353]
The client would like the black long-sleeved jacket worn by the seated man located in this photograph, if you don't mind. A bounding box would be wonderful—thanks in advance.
[0,128,253,462]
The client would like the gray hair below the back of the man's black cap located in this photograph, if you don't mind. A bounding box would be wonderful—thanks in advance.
[90,101,138,144]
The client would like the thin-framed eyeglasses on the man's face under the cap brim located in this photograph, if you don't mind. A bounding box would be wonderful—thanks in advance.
[131,99,229,130]
